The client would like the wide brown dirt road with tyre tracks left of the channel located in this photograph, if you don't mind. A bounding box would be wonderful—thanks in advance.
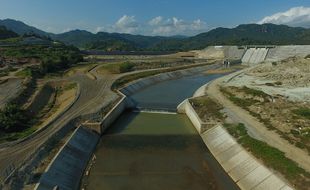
[0,70,118,181]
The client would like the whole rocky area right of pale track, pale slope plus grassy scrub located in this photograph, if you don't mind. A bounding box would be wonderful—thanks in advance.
[222,57,310,156]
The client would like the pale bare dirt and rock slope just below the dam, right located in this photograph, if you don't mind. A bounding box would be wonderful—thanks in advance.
[227,57,310,102]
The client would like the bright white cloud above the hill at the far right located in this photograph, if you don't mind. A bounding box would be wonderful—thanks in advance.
[258,7,310,27]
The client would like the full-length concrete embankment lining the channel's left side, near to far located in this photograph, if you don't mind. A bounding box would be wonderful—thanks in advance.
[36,65,225,190]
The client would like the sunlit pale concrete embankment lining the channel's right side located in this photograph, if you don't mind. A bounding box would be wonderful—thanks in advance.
[178,100,292,190]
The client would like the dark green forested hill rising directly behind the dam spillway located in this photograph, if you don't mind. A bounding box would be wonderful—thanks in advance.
[153,24,310,50]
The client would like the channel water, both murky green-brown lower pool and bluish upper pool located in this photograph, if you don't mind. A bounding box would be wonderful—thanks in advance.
[85,72,238,190]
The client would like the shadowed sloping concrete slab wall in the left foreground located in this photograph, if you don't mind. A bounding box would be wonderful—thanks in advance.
[35,127,100,190]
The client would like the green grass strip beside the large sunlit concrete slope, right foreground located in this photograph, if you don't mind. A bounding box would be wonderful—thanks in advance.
[224,123,310,189]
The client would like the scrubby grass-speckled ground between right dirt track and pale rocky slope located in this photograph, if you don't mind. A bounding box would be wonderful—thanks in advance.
[221,87,310,154]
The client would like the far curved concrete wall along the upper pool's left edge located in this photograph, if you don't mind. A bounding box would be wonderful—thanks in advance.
[120,64,221,96]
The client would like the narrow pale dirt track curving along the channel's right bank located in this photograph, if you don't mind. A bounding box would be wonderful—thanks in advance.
[206,74,310,171]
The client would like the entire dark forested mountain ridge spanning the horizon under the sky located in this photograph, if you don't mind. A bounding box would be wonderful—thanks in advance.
[0,19,310,51]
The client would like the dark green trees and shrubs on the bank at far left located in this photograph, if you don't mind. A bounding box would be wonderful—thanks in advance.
[0,39,83,140]
